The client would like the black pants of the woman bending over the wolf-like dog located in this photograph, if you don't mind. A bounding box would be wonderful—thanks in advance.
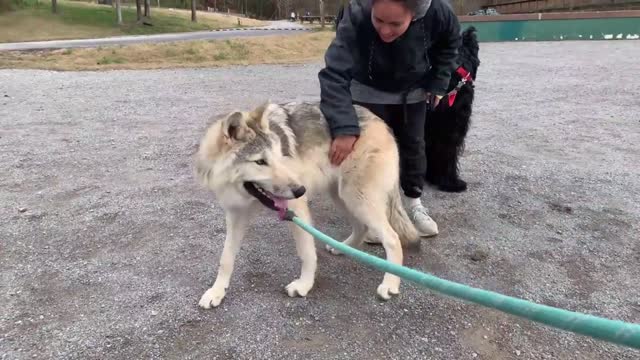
[353,101,427,198]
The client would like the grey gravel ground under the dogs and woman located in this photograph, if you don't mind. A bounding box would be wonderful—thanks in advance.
[0,41,640,359]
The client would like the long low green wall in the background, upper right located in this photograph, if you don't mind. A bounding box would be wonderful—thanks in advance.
[460,17,640,41]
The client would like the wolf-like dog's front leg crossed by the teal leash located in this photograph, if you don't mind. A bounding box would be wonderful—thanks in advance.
[286,197,318,297]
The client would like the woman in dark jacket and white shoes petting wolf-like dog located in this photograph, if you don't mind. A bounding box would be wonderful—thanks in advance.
[318,0,461,236]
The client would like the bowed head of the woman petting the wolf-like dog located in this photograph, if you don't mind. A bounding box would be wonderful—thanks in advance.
[371,0,431,42]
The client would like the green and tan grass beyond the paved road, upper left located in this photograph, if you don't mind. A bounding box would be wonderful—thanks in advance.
[0,0,255,42]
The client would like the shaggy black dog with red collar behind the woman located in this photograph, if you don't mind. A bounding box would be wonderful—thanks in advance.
[425,26,480,192]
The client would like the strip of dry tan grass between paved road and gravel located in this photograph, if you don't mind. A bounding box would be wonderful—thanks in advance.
[0,32,333,70]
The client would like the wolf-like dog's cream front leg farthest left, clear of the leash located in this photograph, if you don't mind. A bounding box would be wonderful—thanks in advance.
[198,210,250,309]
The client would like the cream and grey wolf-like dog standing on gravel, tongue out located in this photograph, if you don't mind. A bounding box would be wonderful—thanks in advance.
[195,103,420,308]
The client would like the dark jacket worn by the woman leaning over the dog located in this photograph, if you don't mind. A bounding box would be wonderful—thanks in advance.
[318,0,461,137]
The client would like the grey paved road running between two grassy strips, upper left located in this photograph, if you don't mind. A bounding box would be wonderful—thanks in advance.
[0,21,309,51]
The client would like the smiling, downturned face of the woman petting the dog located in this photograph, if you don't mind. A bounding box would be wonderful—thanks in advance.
[371,0,413,43]
